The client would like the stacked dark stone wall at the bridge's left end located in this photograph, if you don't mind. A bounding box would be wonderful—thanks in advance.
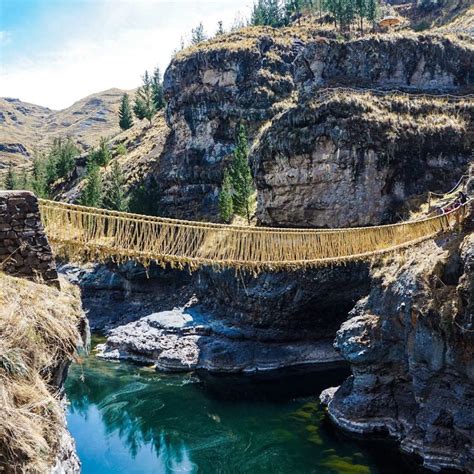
[0,191,59,285]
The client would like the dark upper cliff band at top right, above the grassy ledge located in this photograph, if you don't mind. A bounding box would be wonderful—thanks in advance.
[295,34,474,92]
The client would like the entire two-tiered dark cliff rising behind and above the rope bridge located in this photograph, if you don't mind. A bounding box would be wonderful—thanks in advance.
[161,27,474,227]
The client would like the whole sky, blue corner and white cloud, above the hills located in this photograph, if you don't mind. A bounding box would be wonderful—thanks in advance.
[0,0,253,109]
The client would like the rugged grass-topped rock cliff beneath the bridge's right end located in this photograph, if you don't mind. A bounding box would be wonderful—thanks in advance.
[322,206,474,472]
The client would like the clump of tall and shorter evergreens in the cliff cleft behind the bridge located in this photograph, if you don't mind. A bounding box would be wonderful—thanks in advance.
[219,124,255,224]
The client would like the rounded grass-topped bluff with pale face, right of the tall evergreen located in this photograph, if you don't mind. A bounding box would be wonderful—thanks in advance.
[253,91,474,227]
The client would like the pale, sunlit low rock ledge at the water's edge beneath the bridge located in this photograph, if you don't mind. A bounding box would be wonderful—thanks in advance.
[97,307,341,373]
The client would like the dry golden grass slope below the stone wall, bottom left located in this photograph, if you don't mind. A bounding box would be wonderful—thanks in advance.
[0,272,82,472]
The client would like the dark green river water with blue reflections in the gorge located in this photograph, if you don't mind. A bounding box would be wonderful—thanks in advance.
[66,338,420,474]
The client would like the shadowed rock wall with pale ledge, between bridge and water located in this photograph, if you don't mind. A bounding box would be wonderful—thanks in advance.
[69,264,368,373]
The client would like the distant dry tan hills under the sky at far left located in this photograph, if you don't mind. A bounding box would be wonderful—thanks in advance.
[0,89,133,171]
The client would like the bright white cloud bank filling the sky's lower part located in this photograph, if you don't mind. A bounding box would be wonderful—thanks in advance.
[0,0,252,109]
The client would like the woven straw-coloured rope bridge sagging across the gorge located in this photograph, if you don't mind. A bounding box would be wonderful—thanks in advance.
[39,199,464,272]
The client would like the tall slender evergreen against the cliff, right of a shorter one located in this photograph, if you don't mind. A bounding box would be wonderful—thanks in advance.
[230,124,254,223]
